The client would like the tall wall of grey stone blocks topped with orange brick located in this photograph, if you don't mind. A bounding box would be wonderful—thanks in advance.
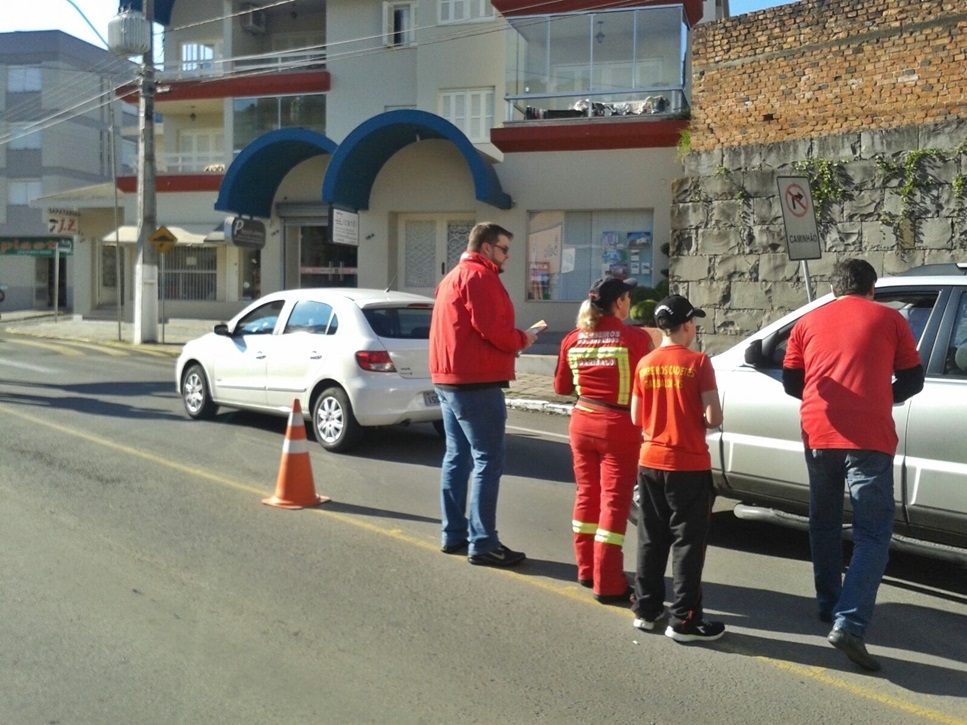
[670,0,967,353]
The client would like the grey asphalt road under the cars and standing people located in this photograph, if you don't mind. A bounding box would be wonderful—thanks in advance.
[0,331,967,724]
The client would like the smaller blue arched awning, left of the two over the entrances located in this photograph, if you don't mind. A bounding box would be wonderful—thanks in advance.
[215,128,336,219]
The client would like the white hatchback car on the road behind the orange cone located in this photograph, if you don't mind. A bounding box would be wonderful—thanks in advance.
[176,288,441,452]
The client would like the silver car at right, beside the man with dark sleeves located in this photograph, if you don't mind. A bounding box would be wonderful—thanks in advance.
[708,265,967,559]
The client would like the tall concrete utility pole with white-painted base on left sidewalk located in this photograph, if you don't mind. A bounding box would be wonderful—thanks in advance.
[132,0,158,345]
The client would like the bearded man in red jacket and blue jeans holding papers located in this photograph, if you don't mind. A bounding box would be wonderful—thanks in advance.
[430,222,537,567]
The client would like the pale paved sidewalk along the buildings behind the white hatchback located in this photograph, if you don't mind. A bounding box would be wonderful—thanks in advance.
[0,310,572,415]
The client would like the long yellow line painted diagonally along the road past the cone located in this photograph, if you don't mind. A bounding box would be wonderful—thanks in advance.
[0,404,967,725]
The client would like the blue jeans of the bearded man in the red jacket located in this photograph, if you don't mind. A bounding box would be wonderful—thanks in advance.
[436,387,507,556]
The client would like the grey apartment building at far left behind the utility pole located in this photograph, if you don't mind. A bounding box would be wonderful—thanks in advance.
[0,30,132,310]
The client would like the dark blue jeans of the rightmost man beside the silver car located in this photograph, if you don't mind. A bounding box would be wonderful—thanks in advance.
[806,449,896,637]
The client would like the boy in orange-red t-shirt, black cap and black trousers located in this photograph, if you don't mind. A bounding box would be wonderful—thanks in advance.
[631,295,725,642]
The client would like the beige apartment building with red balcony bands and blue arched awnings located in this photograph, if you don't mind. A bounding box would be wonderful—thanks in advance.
[47,0,727,330]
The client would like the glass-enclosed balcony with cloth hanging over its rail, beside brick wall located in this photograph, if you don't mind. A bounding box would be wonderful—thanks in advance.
[504,5,689,122]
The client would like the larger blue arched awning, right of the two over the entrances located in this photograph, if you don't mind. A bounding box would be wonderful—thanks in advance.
[322,110,512,210]
